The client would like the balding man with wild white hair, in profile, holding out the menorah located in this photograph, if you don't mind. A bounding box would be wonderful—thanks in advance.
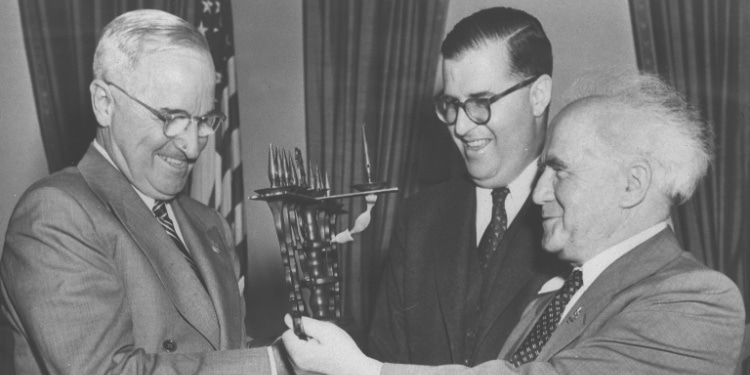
[284,71,745,374]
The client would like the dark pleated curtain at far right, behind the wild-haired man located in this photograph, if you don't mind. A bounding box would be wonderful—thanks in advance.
[630,0,750,370]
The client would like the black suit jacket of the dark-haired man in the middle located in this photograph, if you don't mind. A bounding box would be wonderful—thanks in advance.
[369,179,560,365]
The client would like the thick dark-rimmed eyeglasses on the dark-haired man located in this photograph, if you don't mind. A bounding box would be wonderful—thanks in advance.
[435,76,539,125]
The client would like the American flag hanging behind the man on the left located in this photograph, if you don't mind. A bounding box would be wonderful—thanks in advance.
[190,0,247,274]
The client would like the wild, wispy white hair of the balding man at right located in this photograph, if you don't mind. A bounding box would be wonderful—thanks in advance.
[566,72,714,204]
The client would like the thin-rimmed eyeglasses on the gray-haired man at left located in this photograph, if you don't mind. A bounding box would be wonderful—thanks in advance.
[104,81,227,138]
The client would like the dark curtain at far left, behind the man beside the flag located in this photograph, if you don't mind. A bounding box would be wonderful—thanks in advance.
[19,0,195,173]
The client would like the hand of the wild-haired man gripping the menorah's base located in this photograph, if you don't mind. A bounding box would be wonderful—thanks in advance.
[281,314,383,375]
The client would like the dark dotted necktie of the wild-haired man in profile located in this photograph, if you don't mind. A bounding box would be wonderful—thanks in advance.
[509,269,583,367]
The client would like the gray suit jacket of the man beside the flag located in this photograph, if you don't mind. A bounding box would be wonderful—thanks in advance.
[0,145,282,374]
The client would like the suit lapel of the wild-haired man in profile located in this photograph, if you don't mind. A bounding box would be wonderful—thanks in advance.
[538,228,682,361]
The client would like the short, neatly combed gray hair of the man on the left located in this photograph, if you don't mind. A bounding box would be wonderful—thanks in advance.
[94,9,211,83]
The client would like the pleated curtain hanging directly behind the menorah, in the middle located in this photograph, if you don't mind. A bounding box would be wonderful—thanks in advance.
[303,0,448,325]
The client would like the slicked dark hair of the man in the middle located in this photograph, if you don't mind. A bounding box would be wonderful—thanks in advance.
[441,7,552,77]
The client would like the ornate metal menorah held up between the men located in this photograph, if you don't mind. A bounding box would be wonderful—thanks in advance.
[251,133,398,337]
